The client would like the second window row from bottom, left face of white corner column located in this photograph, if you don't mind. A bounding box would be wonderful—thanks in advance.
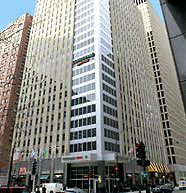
[70,128,96,140]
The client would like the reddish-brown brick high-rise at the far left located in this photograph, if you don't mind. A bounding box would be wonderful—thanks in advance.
[0,13,32,184]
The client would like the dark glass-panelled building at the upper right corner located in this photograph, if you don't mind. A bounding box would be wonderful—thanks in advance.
[160,0,186,113]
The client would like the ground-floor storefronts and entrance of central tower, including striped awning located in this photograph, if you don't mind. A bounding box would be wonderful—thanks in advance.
[9,155,177,193]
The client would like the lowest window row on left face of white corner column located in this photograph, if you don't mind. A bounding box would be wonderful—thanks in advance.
[70,141,96,153]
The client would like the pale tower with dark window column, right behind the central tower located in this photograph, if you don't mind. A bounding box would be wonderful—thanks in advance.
[135,0,186,181]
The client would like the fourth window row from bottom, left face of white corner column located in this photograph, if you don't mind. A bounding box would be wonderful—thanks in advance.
[71,104,96,117]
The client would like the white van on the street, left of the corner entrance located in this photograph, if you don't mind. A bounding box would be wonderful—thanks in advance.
[39,183,63,193]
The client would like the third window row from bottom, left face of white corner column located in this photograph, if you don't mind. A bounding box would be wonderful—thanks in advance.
[70,116,96,128]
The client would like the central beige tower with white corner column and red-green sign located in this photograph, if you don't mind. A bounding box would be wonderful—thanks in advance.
[13,0,167,192]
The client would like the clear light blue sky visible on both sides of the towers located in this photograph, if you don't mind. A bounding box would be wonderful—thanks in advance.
[0,0,163,31]
